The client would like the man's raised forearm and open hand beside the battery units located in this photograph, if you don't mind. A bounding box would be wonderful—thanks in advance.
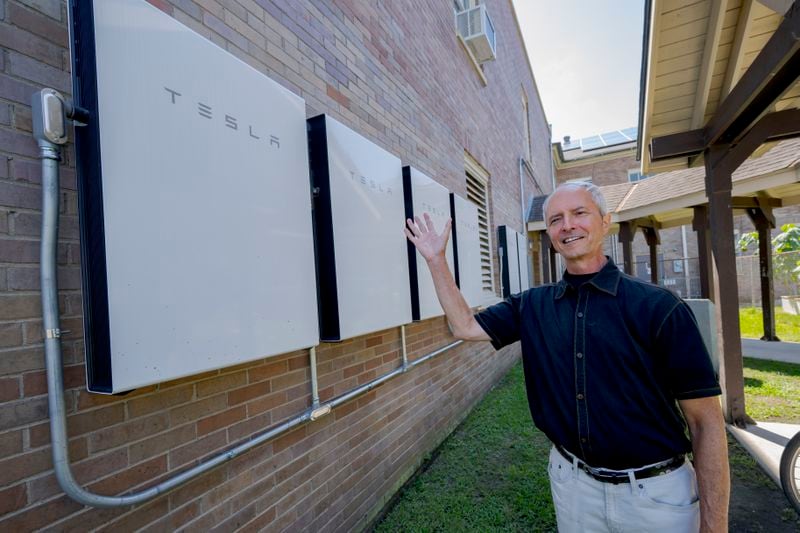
[405,213,490,341]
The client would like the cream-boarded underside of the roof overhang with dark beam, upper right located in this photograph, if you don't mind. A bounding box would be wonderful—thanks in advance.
[639,0,800,173]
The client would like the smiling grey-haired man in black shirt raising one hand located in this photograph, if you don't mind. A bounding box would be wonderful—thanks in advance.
[406,183,730,531]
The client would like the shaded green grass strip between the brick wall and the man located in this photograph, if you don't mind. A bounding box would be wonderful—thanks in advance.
[375,364,556,532]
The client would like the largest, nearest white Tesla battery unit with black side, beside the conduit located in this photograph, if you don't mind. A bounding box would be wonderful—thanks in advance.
[70,0,319,393]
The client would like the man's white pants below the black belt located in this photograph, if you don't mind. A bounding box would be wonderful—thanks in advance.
[549,448,700,533]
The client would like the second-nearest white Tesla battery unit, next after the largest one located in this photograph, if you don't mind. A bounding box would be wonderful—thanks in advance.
[308,115,412,341]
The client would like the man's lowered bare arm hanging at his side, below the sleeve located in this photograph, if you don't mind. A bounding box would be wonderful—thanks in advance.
[678,396,731,532]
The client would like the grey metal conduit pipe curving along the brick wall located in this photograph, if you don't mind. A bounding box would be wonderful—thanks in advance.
[37,104,463,508]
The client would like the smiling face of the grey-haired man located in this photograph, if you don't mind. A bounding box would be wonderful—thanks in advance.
[545,189,611,263]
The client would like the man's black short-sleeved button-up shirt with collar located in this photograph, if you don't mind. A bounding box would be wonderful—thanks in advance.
[475,259,721,469]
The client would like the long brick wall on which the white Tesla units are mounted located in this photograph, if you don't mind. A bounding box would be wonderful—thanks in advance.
[0,0,552,531]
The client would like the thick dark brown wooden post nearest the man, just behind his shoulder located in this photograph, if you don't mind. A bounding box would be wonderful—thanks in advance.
[704,145,752,427]
